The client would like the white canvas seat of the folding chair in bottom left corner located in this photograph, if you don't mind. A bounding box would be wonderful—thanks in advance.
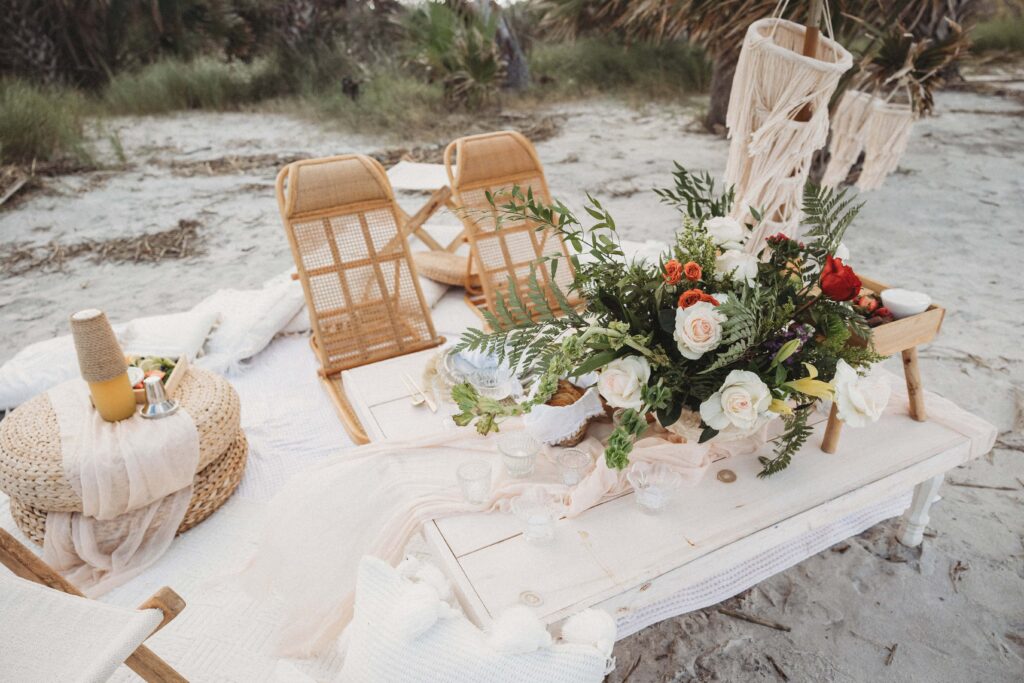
[0,569,163,683]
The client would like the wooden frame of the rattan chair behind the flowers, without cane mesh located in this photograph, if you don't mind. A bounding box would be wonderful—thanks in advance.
[444,130,577,317]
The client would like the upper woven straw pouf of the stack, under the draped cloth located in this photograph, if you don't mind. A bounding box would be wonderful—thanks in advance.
[0,368,240,512]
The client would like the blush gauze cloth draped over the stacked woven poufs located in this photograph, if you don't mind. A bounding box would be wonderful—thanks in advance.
[43,380,199,597]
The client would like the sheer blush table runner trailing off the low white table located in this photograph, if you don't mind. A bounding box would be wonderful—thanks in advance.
[242,422,763,656]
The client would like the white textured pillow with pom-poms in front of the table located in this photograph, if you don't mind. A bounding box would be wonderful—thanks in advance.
[339,556,615,683]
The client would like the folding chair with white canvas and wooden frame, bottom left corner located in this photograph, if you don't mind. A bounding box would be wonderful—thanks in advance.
[0,528,185,683]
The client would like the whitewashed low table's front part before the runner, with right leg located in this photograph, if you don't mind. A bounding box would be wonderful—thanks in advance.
[424,395,995,625]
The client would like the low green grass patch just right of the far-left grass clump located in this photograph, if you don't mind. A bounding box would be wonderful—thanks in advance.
[99,57,267,115]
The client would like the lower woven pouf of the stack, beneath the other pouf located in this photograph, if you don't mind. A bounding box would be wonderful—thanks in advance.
[10,430,249,545]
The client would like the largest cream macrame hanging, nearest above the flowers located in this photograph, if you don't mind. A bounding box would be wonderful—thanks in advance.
[725,12,853,253]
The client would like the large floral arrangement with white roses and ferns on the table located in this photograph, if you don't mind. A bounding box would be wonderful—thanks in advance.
[453,165,884,476]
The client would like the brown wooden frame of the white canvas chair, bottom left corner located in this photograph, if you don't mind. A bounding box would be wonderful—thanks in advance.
[0,528,187,683]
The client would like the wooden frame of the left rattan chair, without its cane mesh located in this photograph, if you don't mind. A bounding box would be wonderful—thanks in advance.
[276,155,446,443]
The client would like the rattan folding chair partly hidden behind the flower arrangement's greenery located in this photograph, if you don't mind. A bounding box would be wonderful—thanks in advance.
[444,130,579,321]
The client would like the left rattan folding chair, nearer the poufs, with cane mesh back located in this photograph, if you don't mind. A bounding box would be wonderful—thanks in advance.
[278,155,444,443]
